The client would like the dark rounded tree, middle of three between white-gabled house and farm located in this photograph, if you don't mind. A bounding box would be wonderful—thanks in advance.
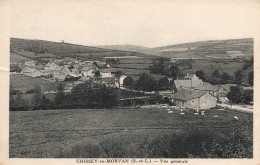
[136,73,157,91]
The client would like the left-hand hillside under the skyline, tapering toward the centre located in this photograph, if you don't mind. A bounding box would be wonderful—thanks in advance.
[10,38,149,62]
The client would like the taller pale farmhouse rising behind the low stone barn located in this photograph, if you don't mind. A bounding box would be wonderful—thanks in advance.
[173,74,203,93]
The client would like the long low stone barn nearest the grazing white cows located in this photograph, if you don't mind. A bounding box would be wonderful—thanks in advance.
[171,89,217,109]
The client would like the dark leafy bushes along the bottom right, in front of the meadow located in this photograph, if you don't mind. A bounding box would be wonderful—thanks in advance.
[54,124,253,158]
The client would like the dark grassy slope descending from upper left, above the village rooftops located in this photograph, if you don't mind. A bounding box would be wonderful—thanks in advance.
[10,38,150,59]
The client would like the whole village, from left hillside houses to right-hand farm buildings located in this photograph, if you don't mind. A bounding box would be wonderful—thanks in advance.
[11,54,252,111]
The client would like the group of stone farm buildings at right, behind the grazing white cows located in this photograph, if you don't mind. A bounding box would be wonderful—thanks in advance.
[159,74,235,109]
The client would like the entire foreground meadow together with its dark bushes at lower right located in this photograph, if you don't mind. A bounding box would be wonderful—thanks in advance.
[10,109,253,158]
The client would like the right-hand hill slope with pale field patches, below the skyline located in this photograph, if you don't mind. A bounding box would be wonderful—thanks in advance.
[139,38,254,58]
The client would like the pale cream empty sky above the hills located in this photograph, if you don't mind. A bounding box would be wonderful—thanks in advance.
[9,0,260,47]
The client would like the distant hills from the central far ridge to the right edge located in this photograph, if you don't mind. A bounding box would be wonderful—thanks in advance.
[97,38,254,59]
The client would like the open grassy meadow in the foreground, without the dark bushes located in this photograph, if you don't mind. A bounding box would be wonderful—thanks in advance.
[9,109,252,158]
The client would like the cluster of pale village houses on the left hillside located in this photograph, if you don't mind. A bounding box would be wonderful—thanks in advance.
[17,58,127,92]
